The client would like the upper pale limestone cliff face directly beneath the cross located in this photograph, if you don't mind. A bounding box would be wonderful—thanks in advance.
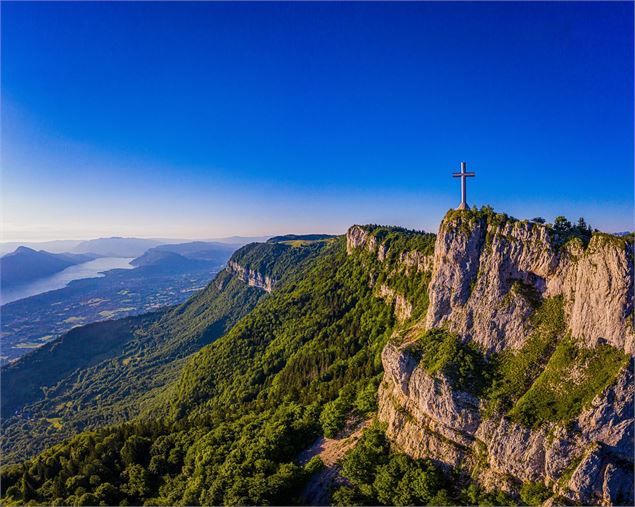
[426,212,634,353]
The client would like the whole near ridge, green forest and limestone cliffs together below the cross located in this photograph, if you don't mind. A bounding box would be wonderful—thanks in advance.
[2,208,633,504]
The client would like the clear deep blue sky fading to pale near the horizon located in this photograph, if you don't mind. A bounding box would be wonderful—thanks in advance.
[2,2,633,240]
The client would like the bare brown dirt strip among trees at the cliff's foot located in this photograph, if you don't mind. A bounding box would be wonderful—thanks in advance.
[298,419,371,505]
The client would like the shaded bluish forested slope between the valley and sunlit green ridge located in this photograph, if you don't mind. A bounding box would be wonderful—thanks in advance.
[1,240,328,463]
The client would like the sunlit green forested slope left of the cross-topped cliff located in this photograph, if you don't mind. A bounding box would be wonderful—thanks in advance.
[3,228,448,504]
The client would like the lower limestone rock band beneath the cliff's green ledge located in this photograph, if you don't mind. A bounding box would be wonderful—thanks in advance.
[379,344,635,505]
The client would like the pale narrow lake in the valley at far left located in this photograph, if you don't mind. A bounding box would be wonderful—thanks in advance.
[0,257,134,305]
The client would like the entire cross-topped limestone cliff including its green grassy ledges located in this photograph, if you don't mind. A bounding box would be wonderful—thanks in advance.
[347,209,634,505]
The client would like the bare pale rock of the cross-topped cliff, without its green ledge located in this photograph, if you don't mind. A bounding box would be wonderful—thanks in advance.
[347,211,635,505]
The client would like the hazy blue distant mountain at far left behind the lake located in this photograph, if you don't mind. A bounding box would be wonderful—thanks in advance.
[0,246,98,286]
